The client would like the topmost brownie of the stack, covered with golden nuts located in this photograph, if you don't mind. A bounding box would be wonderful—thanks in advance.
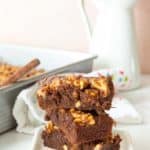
[37,75,114,111]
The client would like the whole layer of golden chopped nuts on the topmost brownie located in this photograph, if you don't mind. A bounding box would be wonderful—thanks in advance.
[38,75,111,102]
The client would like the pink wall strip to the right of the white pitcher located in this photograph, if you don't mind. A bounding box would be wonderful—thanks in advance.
[135,0,150,73]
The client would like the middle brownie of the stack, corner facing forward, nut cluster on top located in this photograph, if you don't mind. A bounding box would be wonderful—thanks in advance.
[46,109,113,144]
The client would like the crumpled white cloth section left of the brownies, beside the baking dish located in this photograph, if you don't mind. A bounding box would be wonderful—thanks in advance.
[13,84,45,134]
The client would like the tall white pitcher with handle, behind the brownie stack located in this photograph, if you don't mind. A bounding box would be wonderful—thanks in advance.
[80,0,140,88]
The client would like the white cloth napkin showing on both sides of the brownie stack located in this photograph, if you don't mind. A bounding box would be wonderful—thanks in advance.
[13,84,142,134]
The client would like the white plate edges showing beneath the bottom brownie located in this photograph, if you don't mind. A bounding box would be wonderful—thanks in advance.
[31,127,133,150]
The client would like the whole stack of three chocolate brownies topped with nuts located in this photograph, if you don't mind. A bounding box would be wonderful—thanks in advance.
[37,75,121,150]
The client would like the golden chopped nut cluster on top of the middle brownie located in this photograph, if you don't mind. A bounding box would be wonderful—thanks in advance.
[70,109,95,126]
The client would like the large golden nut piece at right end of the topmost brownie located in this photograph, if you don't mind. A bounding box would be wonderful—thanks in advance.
[91,77,110,97]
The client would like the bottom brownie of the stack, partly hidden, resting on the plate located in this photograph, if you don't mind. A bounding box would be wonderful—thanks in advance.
[42,123,121,150]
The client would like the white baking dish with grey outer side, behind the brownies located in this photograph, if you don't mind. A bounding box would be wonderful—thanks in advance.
[0,45,96,133]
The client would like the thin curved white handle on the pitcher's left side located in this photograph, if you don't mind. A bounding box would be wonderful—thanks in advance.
[79,0,92,41]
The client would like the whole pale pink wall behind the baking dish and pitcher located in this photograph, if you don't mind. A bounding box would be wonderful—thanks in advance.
[0,0,150,73]
